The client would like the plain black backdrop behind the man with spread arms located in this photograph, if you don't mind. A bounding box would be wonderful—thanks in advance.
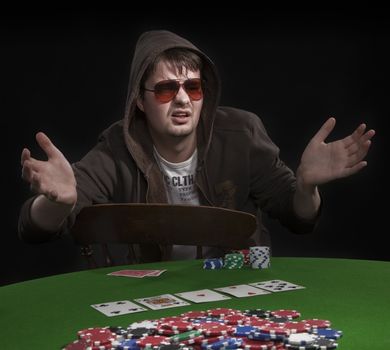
[0,11,390,284]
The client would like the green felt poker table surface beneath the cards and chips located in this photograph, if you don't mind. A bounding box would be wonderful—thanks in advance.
[0,257,390,350]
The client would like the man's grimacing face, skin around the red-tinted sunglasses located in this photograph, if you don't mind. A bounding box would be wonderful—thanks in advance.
[137,61,203,142]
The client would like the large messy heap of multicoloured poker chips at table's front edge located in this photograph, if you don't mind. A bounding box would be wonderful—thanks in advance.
[62,308,342,350]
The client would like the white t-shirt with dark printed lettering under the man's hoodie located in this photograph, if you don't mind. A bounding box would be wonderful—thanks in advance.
[154,148,224,260]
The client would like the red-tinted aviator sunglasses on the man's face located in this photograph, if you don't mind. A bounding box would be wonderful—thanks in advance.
[143,78,203,103]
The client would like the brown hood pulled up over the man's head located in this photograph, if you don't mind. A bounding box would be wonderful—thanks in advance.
[123,30,220,173]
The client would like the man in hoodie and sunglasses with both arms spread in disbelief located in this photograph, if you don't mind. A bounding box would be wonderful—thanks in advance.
[19,31,374,261]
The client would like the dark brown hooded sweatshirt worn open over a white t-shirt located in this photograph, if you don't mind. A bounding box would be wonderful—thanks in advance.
[19,30,317,261]
